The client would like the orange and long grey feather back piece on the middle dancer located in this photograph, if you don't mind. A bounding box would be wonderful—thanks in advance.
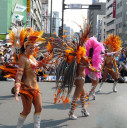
[47,25,90,105]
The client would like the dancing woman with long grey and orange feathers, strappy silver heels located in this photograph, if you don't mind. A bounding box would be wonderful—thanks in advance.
[52,26,98,119]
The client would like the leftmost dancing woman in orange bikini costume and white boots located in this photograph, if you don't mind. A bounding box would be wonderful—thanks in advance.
[9,29,47,128]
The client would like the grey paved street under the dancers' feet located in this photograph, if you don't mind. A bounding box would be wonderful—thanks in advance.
[0,81,127,128]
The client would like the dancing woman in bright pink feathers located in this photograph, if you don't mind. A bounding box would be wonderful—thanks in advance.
[85,37,104,100]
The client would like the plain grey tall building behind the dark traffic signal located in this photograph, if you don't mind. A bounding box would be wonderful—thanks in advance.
[87,3,106,37]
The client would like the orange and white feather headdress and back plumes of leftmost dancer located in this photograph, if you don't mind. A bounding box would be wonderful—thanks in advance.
[0,28,45,78]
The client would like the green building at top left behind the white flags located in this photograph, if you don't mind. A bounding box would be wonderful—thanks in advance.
[0,0,27,34]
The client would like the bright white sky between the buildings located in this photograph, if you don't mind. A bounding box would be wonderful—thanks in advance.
[49,0,106,32]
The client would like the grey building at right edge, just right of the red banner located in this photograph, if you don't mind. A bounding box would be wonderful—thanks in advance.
[115,0,127,45]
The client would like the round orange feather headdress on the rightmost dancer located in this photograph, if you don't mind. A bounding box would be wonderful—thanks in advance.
[104,34,122,52]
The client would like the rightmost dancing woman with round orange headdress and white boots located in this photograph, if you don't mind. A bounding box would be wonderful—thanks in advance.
[98,35,121,92]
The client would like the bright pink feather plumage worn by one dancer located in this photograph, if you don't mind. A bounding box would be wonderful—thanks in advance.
[85,37,105,78]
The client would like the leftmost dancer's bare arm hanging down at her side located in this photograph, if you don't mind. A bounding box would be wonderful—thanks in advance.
[15,57,25,101]
